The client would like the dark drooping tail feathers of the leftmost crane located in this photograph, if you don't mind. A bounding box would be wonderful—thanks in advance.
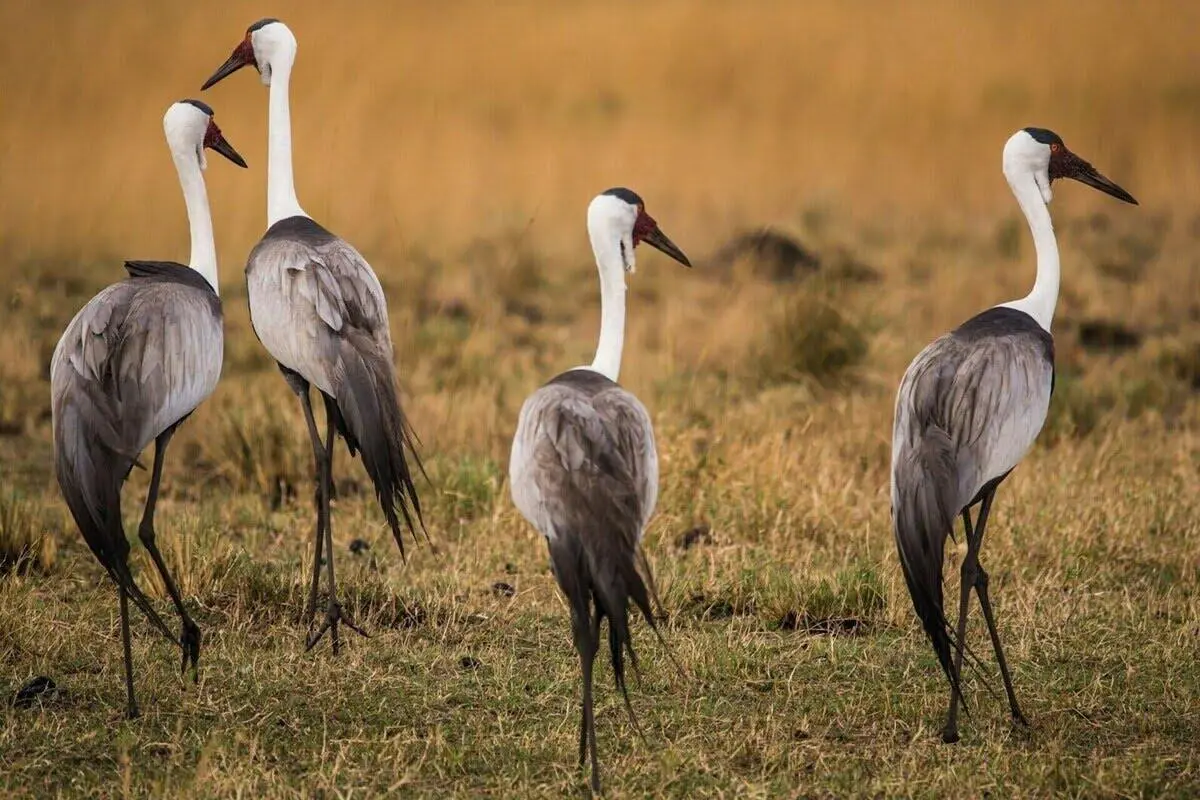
[53,381,179,645]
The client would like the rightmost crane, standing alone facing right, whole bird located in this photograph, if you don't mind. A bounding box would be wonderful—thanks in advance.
[892,127,1138,744]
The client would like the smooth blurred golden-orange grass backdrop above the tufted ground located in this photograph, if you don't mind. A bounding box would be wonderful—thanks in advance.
[7,0,1200,257]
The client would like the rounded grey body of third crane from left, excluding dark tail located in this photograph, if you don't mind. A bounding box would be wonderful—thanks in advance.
[509,368,659,544]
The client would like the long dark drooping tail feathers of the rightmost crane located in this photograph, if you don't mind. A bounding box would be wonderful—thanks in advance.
[892,427,961,699]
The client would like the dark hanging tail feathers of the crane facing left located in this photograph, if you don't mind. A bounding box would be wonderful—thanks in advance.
[334,333,428,557]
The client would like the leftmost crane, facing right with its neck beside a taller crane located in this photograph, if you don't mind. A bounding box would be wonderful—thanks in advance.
[50,100,246,718]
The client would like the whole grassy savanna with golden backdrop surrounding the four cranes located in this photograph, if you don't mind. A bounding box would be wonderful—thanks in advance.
[0,0,1200,798]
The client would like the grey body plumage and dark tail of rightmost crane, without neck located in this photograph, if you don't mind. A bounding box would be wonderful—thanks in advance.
[892,307,1054,738]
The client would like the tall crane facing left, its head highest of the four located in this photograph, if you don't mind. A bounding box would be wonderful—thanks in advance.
[202,18,428,655]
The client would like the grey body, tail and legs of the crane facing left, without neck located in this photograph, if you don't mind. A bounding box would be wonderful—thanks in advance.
[246,216,421,650]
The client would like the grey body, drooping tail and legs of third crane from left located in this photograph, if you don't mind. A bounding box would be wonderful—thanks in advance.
[509,368,659,788]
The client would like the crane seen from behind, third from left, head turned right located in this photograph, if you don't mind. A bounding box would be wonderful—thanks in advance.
[509,188,691,792]
